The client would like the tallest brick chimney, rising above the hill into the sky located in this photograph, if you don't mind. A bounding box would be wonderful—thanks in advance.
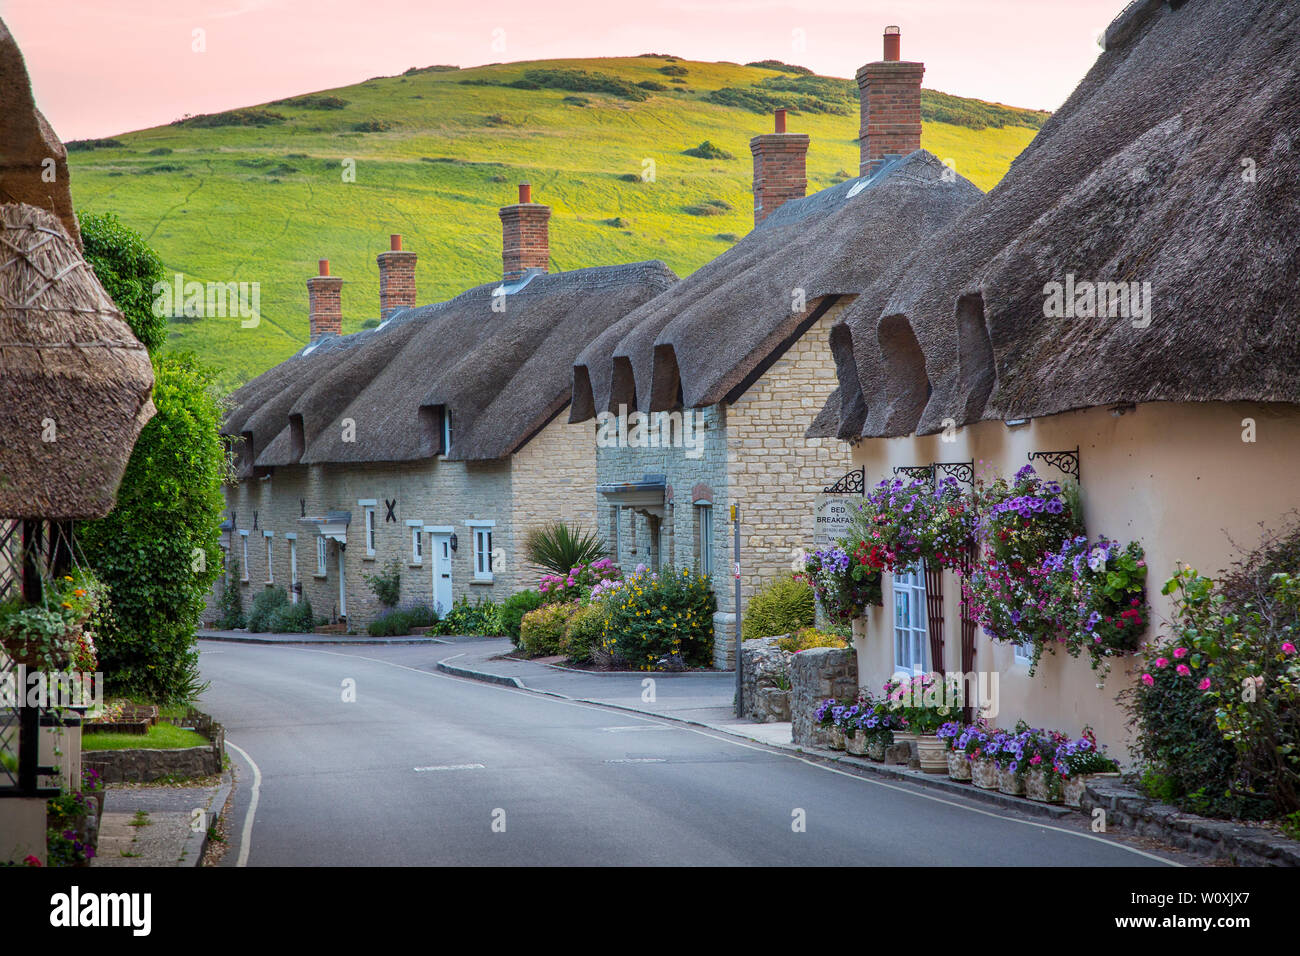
[858,26,926,176]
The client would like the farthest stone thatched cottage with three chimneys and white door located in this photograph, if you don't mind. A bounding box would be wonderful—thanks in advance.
[222,191,676,627]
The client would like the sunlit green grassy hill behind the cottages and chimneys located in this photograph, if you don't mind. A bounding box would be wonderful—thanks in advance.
[69,56,1045,386]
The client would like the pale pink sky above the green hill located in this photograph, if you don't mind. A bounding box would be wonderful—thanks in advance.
[0,0,1125,139]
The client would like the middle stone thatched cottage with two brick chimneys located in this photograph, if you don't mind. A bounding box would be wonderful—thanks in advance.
[569,27,983,666]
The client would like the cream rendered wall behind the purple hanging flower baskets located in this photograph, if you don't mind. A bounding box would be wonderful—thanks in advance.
[853,403,1300,757]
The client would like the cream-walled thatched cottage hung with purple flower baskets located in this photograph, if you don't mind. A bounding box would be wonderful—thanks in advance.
[809,0,1300,744]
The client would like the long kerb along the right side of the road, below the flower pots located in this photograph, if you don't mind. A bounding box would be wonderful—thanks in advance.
[437,661,1079,819]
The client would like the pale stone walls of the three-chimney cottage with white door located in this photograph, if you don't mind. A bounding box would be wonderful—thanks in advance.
[208,415,595,630]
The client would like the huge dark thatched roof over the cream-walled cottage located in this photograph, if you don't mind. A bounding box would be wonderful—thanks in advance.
[810,0,1300,438]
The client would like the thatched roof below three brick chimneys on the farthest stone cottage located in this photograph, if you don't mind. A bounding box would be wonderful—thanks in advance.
[222,261,676,473]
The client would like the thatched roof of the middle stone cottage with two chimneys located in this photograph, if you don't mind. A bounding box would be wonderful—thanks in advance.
[569,150,983,421]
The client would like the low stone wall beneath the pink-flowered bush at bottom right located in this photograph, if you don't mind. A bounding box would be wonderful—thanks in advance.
[1082,780,1300,866]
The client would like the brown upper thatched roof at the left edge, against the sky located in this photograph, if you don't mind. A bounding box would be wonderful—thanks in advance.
[0,20,82,251]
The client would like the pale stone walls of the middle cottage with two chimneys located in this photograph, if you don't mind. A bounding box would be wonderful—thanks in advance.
[595,299,853,667]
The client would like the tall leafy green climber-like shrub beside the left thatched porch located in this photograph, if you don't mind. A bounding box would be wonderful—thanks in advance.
[77,216,229,702]
